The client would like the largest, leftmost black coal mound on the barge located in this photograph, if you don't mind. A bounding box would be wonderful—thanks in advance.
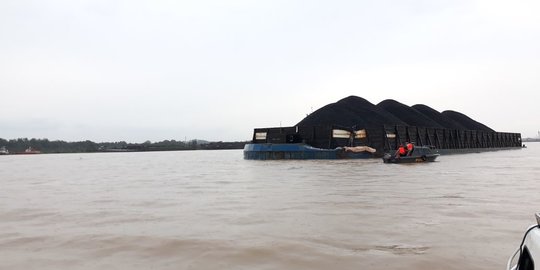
[297,96,406,128]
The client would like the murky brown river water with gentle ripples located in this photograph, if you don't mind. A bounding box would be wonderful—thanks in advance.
[0,143,540,270]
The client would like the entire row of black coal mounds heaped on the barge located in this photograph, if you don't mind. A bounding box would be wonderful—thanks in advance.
[297,96,493,132]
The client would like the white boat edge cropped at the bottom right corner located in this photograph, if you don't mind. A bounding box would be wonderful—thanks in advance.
[506,213,540,270]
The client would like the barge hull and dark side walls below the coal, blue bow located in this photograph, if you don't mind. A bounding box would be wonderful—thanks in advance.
[244,125,522,160]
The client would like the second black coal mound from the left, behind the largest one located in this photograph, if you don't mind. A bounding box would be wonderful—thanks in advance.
[377,99,443,128]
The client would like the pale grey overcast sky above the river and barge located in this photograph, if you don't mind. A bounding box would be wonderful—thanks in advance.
[0,0,540,142]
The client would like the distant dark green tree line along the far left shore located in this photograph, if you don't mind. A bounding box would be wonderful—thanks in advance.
[0,138,247,153]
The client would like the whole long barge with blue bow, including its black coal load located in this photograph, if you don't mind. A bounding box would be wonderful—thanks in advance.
[244,96,522,160]
